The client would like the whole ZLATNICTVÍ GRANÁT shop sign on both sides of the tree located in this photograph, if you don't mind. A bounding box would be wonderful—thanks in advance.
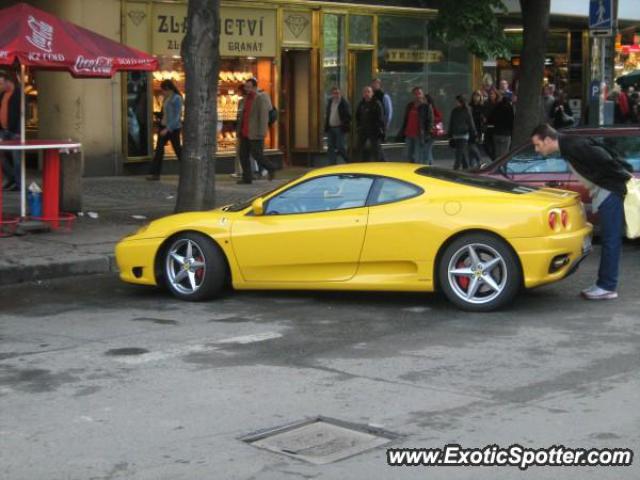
[151,3,276,57]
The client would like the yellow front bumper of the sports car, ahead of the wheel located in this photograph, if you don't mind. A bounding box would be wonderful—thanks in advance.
[116,237,163,285]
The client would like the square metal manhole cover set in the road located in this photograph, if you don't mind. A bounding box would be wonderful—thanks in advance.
[240,417,398,465]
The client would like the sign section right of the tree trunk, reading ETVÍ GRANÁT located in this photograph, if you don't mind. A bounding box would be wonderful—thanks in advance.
[220,8,276,57]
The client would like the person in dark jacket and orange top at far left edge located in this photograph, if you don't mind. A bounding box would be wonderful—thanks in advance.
[0,72,22,191]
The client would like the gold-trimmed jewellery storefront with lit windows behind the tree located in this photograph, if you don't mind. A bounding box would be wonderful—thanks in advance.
[122,0,472,171]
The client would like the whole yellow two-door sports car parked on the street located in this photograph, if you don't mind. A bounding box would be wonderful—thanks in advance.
[116,163,592,311]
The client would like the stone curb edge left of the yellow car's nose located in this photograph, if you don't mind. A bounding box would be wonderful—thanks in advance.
[0,255,118,285]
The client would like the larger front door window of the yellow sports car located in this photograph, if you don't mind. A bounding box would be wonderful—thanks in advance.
[265,175,373,215]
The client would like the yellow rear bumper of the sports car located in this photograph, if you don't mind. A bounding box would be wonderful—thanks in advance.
[510,225,593,288]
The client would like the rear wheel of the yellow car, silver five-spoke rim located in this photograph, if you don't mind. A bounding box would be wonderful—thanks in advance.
[438,233,522,312]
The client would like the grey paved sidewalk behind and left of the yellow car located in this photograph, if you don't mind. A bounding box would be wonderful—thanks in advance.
[0,160,460,285]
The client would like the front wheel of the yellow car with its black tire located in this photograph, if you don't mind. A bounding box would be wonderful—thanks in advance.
[160,232,228,302]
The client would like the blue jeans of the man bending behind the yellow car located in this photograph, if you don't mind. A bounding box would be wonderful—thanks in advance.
[596,193,624,292]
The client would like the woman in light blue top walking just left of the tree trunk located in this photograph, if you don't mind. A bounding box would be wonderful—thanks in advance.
[147,80,184,180]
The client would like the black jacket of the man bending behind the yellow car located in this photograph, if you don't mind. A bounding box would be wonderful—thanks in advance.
[558,135,633,196]
